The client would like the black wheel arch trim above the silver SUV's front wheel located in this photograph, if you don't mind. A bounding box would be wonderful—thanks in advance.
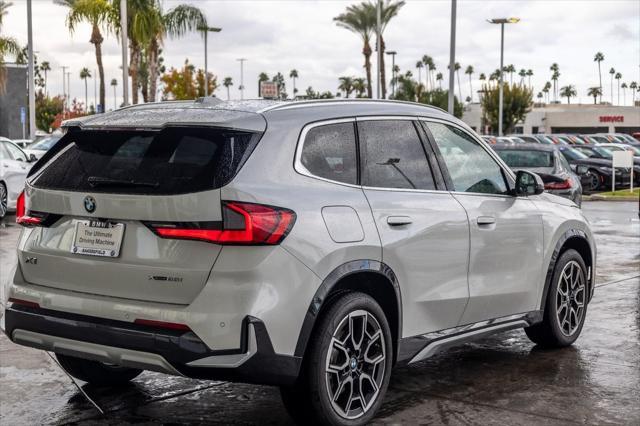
[540,229,595,311]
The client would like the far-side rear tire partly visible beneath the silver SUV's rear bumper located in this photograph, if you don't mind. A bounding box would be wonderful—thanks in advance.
[56,353,142,386]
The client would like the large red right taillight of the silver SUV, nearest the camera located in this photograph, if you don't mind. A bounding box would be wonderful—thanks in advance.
[147,201,296,245]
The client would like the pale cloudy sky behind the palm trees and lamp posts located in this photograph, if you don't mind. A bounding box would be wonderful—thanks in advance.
[3,0,640,108]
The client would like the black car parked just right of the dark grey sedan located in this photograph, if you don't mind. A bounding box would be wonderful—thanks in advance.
[557,145,631,191]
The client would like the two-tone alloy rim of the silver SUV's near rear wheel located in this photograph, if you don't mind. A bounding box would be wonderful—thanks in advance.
[325,310,386,419]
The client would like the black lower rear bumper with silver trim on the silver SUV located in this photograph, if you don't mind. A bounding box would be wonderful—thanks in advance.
[3,304,301,385]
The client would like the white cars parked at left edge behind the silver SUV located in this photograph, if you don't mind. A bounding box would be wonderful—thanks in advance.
[0,134,62,219]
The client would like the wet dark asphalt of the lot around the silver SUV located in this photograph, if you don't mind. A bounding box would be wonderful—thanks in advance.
[0,202,640,425]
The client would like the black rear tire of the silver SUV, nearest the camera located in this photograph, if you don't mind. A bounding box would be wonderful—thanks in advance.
[280,292,393,426]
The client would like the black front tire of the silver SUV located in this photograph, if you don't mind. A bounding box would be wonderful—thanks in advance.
[524,249,589,348]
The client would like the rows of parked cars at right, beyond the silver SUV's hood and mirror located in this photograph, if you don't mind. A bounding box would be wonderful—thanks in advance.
[482,134,640,204]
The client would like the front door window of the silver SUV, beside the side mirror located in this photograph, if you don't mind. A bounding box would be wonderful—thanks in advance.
[427,123,507,194]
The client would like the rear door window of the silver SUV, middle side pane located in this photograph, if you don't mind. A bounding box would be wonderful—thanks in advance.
[358,120,435,189]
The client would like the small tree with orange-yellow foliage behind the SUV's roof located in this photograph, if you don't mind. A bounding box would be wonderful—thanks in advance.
[160,59,217,100]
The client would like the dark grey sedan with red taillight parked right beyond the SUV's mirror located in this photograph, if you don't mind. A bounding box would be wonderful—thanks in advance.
[492,143,582,205]
